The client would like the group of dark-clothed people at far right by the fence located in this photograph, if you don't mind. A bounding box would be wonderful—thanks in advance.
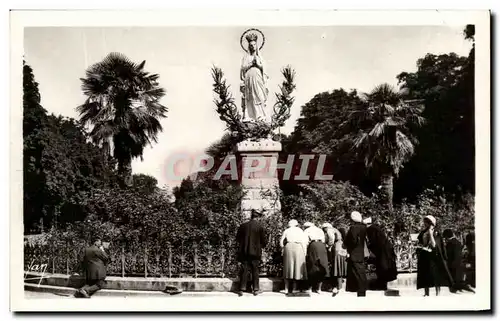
[417,215,476,296]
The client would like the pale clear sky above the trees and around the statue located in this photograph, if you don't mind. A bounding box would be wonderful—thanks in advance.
[24,26,471,187]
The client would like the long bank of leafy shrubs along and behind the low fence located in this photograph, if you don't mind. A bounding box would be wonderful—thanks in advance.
[25,182,474,276]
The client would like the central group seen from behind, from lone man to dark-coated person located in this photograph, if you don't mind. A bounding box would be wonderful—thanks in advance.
[237,211,397,296]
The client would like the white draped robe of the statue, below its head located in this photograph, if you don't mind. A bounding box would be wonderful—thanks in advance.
[240,53,268,120]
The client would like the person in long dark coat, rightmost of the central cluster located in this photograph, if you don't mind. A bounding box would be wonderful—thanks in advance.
[364,217,398,290]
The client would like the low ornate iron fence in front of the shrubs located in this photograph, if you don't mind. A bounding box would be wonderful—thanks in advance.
[24,234,417,278]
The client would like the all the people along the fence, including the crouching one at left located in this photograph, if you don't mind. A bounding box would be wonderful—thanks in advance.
[69,211,475,298]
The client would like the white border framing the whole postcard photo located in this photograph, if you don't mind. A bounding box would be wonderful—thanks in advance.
[10,10,492,312]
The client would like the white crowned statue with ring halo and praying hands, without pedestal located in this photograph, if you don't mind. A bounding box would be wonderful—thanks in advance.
[240,29,269,121]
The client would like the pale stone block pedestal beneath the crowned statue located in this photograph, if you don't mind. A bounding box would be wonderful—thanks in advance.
[236,139,281,219]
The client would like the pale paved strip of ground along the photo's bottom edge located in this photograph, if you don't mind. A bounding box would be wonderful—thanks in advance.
[24,288,474,300]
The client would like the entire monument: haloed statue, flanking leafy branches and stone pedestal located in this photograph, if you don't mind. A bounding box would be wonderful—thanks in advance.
[212,28,295,217]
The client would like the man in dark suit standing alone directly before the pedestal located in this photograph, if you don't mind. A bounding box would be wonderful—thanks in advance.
[236,210,267,296]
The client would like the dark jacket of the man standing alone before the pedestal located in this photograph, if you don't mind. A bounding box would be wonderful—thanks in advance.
[236,219,267,261]
